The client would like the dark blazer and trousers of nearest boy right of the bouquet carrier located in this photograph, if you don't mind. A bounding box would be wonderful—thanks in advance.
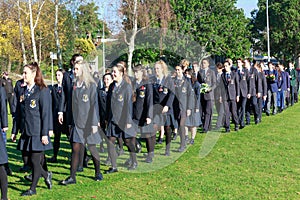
[222,71,240,132]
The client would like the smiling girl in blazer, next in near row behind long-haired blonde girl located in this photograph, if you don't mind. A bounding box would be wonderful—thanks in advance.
[105,64,137,174]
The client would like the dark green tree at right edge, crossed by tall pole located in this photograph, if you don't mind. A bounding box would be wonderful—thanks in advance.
[252,0,300,60]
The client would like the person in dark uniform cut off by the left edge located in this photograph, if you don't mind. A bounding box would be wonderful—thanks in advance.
[0,86,8,199]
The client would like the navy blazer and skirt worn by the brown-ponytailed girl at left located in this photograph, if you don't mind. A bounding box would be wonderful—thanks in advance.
[17,85,53,152]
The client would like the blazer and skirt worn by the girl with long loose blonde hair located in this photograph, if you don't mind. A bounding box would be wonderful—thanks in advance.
[70,82,101,145]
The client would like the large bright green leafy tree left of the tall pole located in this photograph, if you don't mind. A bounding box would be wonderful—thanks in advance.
[171,0,251,59]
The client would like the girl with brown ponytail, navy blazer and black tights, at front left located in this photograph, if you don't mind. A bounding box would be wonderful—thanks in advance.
[12,63,53,196]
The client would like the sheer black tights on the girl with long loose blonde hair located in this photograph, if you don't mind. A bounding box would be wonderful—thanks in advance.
[71,142,100,179]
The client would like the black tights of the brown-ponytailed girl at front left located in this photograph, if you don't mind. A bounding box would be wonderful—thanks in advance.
[30,151,48,191]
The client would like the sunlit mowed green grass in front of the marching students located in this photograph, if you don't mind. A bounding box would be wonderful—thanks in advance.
[7,103,300,200]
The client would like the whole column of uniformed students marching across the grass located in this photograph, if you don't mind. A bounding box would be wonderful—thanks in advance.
[0,54,299,199]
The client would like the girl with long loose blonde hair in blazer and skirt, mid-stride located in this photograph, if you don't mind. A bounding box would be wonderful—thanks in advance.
[60,61,103,185]
